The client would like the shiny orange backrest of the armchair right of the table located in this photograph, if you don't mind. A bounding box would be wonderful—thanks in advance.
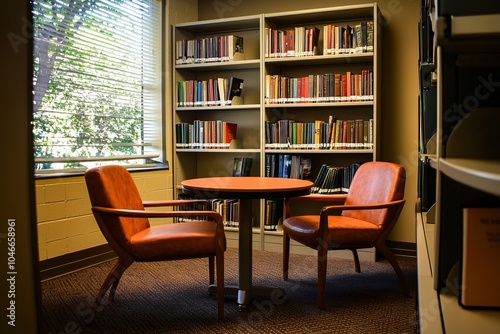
[342,161,406,226]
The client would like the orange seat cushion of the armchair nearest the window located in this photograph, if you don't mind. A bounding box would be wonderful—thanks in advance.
[130,221,222,261]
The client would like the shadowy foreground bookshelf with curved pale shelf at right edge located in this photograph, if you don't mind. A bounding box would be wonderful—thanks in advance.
[416,1,500,333]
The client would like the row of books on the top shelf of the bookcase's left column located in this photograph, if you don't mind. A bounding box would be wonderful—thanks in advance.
[175,35,244,65]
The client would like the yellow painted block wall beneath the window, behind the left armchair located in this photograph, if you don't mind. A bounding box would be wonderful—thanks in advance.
[35,170,172,260]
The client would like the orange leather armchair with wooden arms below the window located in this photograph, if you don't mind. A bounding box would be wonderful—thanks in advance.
[85,165,226,320]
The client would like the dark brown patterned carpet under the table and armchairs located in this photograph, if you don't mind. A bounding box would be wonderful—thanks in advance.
[42,248,418,334]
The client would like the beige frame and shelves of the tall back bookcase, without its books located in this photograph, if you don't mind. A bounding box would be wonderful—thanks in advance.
[173,3,383,259]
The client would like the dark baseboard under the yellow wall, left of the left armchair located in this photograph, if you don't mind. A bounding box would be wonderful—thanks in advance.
[39,244,116,282]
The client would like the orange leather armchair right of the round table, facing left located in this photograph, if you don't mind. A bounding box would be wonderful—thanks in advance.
[283,162,409,309]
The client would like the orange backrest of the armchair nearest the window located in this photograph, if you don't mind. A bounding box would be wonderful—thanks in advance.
[85,165,150,250]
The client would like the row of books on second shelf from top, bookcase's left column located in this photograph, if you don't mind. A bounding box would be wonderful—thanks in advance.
[177,77,243,107]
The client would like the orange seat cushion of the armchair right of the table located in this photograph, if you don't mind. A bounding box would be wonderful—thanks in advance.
[283,215,382,248]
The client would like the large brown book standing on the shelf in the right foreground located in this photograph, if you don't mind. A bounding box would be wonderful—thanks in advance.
[460,207,500,307]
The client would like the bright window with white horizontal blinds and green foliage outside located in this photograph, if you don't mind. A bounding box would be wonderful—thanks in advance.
[32,0,165,173]
